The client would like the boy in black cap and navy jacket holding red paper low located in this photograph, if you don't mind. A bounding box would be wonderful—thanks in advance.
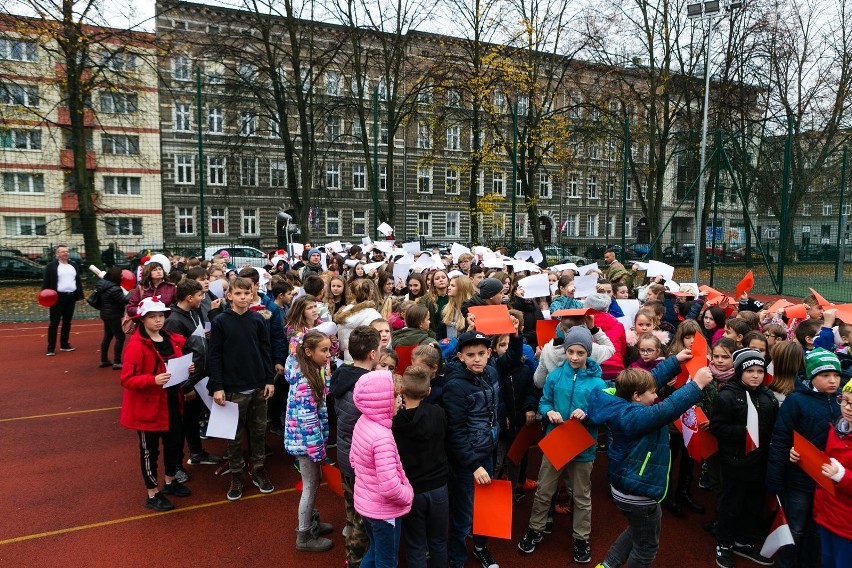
[444,330,501,568]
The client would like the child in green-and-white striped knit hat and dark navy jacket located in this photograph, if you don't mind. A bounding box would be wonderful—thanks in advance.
[766,348,840,567]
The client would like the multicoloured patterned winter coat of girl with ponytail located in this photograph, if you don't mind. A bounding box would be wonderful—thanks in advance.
[284,355,331,462]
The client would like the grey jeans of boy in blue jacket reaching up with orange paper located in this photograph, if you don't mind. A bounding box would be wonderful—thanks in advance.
[604,500,661,568]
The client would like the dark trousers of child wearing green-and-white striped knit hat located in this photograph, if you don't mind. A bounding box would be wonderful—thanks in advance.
[777,488,819,568]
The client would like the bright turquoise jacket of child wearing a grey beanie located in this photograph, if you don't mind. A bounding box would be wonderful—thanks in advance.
[538,359,606,463]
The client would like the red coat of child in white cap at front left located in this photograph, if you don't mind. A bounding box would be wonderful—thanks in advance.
[119,329,185,432]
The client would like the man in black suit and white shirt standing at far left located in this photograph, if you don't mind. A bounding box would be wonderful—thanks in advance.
[41,245,83,357]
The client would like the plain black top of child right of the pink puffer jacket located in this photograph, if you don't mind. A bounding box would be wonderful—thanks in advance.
[393,401,450,493]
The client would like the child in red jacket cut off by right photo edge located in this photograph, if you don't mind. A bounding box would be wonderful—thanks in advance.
[814,381,852,568]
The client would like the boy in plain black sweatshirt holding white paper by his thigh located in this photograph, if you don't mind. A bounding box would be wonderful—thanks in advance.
[207,277,275,501]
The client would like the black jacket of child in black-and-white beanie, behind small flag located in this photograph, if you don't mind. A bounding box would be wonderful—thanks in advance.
[710,379,778,481]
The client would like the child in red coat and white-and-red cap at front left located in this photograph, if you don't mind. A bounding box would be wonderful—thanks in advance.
[120,297,193,511]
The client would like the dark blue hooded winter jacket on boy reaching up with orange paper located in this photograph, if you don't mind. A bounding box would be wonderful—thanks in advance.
[588,357,701,501]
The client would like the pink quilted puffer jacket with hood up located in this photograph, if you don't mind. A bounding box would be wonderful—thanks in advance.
[349,371,414,520]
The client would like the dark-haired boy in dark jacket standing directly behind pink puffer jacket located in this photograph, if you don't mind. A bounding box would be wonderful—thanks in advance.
[331,325,379,566]
